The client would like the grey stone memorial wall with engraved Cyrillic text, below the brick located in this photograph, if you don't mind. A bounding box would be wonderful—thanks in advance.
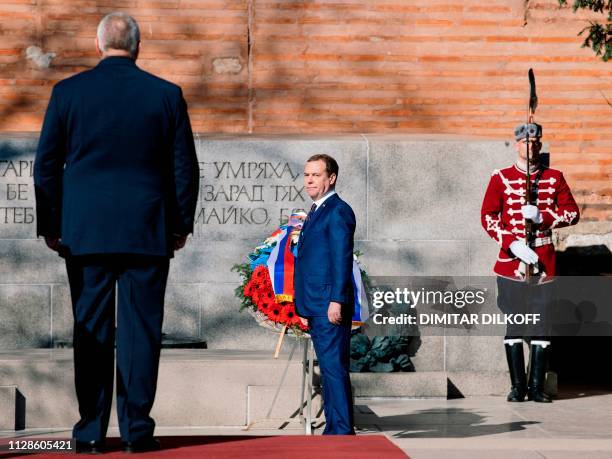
[0,135,528,378]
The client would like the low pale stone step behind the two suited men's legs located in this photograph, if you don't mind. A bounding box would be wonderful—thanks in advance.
[0,349,447,428]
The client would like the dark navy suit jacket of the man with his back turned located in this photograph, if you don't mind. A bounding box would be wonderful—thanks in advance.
[34,57,199,256]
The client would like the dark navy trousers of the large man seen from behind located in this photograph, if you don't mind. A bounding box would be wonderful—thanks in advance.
[66,255,170,442]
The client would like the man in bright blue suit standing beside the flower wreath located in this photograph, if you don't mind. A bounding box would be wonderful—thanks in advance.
[294,155,355,435]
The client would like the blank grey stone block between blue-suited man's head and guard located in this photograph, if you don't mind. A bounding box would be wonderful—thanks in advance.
[368,136,513,240]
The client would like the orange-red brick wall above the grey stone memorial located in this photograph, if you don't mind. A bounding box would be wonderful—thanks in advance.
[0,0,612,222]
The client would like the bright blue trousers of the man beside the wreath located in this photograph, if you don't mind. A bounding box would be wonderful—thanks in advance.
[308,317,355,435]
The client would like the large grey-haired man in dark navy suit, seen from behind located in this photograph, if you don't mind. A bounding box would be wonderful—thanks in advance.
[34,13,199,453]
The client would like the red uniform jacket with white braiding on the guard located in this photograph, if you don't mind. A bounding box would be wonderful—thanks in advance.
[480,165,580,282]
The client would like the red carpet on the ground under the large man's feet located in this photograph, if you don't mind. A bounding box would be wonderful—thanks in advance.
[0,435,408,459]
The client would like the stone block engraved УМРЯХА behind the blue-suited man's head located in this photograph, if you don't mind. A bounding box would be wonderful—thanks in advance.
[194,137,367,241]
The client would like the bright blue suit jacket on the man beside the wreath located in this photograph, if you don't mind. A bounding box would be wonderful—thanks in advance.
[294,194,355,319]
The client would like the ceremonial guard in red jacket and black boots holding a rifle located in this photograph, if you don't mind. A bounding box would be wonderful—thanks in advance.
[481,70,580,403]
